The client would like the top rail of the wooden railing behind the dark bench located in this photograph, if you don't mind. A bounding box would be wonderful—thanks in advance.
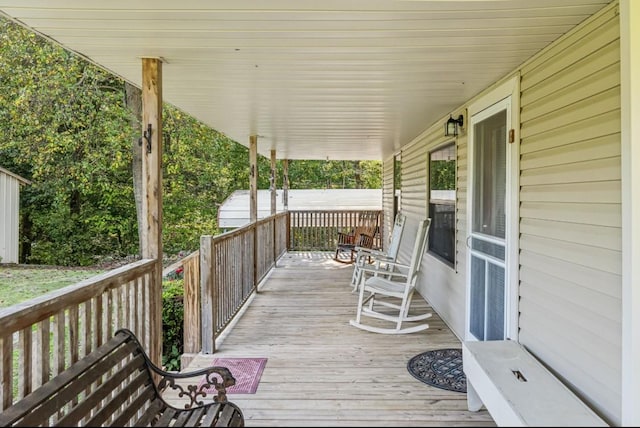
[0,259,156,335]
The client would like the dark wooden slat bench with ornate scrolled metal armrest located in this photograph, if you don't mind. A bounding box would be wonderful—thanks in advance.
[0,330,244,427]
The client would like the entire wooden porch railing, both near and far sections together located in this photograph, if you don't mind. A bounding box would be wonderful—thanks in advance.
[0,211,378,402]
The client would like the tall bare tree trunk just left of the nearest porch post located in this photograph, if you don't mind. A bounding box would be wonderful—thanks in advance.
[124,82,142,254]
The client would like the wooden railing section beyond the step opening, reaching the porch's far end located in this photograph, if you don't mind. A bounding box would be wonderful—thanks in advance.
[179,211,381,366]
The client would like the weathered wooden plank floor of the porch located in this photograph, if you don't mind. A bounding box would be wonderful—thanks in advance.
[175,252,495,427]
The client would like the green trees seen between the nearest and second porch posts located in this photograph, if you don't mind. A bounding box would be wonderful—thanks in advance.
[163,107,249,254]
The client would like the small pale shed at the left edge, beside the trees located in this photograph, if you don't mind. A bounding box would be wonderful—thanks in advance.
[0,167,31,263]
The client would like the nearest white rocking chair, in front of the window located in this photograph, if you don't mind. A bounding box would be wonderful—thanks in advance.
[349,218,432,334]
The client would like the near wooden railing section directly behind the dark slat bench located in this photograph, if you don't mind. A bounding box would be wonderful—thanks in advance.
[0,259,161,410]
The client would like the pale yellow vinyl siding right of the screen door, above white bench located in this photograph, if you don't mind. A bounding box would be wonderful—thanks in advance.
[519,5,622,425]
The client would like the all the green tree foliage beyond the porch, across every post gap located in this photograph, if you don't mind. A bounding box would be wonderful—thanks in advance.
[0,17,382,266]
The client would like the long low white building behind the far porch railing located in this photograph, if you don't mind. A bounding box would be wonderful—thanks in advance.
[218,189,382,230]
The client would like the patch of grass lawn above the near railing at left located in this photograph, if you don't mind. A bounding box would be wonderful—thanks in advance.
[0,265,105,308]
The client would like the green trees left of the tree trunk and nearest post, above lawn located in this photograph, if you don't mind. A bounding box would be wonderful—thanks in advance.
[0,20,137,265]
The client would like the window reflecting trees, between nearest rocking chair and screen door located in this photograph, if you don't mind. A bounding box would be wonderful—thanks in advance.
[429,143,456,266]
